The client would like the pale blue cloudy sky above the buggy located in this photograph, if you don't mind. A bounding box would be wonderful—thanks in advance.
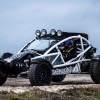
[0,0,100,54]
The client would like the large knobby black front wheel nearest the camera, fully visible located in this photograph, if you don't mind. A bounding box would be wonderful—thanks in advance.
[29,62,52,86]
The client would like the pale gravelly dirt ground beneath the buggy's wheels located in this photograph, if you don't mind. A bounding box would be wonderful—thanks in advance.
[0,74,100,93]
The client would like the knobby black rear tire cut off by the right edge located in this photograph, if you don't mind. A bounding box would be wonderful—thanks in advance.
[90,61,100,84]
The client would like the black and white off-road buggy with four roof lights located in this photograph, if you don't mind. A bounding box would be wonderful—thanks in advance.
[0,29,100,86]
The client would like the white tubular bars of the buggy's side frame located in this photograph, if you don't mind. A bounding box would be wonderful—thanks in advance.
[31,35,92,68]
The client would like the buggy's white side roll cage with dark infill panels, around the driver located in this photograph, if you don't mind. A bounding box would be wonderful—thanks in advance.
[31,35,92,68]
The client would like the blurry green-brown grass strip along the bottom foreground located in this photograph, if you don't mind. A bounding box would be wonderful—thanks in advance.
[0,88,100,100]
